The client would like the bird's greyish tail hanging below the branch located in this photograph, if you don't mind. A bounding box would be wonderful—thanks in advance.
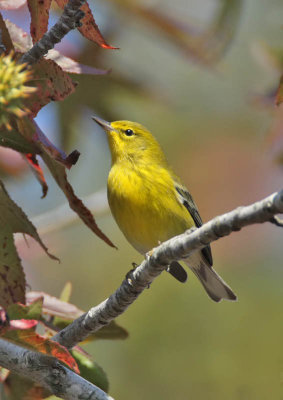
[185,253,237,302]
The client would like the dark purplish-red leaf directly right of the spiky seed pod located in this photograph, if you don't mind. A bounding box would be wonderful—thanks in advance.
[25,58,76,117]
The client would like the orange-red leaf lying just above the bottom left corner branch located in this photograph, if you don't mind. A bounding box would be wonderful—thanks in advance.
[0,329,80,374]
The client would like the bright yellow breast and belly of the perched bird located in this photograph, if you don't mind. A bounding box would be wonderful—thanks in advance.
[108,162,194,254]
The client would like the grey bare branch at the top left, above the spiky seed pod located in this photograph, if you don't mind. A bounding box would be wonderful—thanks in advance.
[20,0,85,64]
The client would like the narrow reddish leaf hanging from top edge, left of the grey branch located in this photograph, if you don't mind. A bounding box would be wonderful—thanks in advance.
[27,0,52,43]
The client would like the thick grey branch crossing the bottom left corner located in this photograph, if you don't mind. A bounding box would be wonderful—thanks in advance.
[0,339,113,400]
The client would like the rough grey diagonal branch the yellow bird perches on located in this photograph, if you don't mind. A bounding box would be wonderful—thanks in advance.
[53,190,283,348]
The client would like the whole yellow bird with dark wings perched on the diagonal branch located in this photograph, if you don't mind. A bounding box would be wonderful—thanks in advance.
[93,117,237,302]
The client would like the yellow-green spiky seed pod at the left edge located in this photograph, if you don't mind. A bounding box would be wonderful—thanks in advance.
[0,52,36,130]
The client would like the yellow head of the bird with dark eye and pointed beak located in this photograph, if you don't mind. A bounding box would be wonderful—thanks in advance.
[92,117,166,164]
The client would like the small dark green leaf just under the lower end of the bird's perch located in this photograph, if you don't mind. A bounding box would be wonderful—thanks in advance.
[71,350,109,392]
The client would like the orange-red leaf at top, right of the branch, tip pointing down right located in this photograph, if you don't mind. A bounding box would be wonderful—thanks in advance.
[56,0,118,49]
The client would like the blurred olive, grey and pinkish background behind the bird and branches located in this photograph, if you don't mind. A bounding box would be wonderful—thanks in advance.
[1,0,283,400]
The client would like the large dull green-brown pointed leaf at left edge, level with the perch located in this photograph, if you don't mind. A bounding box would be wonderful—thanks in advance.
[0,181,55,308]
